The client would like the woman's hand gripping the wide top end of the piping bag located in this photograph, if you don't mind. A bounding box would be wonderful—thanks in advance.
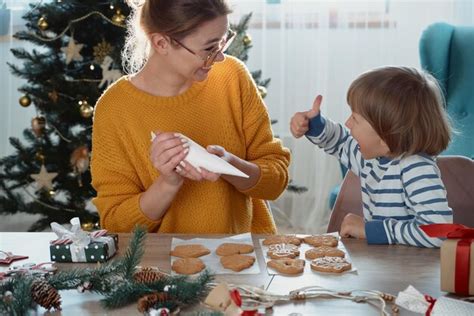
[150,132,189,186]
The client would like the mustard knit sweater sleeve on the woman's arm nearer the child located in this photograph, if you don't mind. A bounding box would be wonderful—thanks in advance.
[238,60,290,200]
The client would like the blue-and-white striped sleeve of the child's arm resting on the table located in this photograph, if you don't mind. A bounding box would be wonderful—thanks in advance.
[366,159,453,248]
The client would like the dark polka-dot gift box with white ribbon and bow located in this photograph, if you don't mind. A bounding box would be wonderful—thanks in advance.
[49,217,118,262]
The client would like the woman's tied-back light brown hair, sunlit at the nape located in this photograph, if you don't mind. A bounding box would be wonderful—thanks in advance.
[122,0,232,73]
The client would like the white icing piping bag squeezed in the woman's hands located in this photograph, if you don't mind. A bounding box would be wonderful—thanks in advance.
[151,132,249,178]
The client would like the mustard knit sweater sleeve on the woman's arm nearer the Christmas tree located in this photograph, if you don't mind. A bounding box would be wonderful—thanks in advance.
[91,96,160,232]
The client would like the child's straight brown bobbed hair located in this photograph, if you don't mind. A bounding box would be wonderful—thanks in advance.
[347,67,451,156]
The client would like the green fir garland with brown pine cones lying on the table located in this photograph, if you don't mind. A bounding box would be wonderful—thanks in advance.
[0,227,213,315]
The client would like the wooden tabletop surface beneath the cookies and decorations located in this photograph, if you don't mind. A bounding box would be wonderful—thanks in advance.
[0,233,444,316]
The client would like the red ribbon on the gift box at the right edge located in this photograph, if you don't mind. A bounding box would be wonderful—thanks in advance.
[420,224,474,295]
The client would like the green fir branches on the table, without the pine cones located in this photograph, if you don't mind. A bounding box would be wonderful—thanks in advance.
[0,227,213,316]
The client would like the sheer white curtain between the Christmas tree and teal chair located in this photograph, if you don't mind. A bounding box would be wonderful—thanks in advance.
[231,0,473,233]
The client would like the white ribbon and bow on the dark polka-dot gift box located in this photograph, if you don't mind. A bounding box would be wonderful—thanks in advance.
[51,217,115,262]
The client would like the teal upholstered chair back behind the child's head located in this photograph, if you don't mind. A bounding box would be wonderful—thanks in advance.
[419,23,474,159]
